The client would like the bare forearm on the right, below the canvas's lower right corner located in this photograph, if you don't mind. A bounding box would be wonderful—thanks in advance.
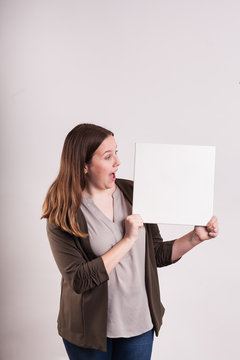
[172,230,201,261]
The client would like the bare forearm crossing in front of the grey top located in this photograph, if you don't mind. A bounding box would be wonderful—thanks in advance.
[102,237,135,275]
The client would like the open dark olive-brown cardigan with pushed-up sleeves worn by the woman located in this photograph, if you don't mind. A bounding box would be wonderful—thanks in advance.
[46,179,180,352]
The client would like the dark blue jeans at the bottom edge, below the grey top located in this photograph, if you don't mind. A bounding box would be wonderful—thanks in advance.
[62,329,154,360]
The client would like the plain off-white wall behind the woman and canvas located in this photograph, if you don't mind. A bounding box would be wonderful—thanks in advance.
[0,0,240,360]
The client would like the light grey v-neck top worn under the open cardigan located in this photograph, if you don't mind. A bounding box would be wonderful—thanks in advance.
[80,186,153,338]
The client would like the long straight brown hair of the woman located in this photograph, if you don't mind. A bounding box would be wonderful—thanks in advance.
[40,123,114,238]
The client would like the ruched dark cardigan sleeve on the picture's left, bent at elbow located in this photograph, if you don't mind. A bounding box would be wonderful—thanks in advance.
[46,219,109,294]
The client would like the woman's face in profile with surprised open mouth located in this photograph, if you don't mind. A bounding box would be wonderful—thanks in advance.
[85,135,120,189]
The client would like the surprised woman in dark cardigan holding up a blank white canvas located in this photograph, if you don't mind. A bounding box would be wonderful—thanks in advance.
[41,124,218,360]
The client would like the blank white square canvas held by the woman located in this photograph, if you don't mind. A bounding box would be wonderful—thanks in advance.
[132,143,216,226]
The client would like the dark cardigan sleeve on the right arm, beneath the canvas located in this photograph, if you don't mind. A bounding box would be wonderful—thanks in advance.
[149,224,181,267]
